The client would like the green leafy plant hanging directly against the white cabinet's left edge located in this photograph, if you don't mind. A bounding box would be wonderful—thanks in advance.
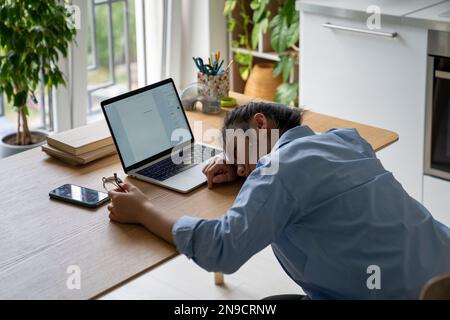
[270,0,300,105]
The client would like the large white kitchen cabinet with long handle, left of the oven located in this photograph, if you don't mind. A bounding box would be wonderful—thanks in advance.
[300,12,427,201]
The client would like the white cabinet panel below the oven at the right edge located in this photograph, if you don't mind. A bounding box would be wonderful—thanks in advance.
[423,176,450,227]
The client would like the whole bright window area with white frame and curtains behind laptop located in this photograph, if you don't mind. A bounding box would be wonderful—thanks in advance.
[33,0,220,131]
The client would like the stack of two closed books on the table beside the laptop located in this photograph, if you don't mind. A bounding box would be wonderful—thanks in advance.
[42,121,116,165]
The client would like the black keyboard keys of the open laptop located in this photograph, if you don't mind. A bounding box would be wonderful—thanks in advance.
[137,145,221,181]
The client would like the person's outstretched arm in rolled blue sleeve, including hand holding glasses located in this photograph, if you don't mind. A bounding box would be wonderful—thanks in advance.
[108,164,297,273]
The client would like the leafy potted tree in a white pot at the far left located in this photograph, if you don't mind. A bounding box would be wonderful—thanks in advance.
[0,0,76,156]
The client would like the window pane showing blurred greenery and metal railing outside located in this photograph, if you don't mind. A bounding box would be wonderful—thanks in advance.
[87,0,138,122]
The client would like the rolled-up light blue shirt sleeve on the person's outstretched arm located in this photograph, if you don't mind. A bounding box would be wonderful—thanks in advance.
[172,169,295,274]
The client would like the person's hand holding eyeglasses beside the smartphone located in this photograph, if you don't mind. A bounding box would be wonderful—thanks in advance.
[108,184,152,224]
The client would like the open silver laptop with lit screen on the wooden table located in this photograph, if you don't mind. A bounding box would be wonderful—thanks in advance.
[101,79,222,193]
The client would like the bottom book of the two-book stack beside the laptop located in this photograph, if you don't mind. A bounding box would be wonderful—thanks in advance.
[42,144,116,165]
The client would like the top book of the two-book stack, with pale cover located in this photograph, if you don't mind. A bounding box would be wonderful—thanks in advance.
[47,121,114,156]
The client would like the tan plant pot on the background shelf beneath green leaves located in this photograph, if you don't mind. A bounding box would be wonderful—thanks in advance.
[244,63,283,101]
